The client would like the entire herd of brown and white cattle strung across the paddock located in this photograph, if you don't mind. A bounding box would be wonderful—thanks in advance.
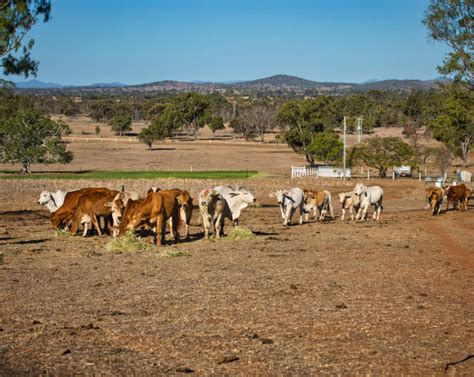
[38,183,472,246]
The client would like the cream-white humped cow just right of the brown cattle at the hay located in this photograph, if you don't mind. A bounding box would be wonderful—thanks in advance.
[199,186,256,240]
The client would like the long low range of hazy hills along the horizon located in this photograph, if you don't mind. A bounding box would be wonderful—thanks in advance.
[17,75,442,96]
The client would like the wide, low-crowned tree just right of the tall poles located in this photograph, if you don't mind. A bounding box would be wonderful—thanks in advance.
[356,136,415,178]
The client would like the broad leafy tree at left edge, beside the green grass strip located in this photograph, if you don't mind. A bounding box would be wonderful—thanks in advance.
[0,109,74,173]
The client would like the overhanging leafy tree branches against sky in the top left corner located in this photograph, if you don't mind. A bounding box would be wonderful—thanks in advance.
[0,0,51,77]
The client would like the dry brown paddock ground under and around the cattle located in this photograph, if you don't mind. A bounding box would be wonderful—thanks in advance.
[0,178,474,376]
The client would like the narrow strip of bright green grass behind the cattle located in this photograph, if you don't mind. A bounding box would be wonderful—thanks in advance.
[0,170,257,179]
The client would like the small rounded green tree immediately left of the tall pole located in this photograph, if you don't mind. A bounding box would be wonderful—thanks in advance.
[308,129,344,165]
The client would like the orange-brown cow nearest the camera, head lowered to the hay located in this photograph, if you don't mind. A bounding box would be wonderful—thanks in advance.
[126,190,180,246]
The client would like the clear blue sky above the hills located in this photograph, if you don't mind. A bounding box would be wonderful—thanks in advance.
[3,0,447,85]
